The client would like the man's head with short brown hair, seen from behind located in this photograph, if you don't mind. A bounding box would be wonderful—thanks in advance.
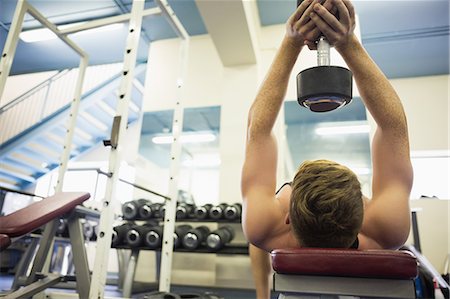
[289,160,364,248]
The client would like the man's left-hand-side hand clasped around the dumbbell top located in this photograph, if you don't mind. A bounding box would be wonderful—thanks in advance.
[286,0,336,50]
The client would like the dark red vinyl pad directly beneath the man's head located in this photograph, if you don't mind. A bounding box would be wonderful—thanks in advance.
[271,248,417,279]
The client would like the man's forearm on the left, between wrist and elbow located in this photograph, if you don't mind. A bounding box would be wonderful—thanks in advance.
[248,38,303,135]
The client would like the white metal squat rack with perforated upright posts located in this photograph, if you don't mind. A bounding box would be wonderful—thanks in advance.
[0,0,189,298]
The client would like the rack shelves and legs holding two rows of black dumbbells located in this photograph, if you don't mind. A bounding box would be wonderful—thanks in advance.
[112,213,248,298]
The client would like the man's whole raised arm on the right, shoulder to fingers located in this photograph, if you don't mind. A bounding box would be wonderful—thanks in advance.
[311,0,413,248]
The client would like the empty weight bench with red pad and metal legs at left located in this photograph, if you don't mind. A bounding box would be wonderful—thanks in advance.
[0,192,90,298]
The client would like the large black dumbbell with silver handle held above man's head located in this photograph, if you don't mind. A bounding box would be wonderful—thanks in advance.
[297,0,352,112]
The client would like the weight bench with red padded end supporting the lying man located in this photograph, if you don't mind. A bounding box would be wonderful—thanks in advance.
[271,248,418,299]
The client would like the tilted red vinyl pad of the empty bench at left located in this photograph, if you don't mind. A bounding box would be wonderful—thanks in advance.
[0,192,90,238]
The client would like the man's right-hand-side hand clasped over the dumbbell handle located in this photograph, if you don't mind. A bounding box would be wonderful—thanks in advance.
[306,0,355,50]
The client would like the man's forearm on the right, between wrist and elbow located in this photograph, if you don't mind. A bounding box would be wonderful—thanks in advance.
[336,35,406,133]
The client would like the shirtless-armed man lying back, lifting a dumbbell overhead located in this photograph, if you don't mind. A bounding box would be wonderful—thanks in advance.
[241,0,413,298]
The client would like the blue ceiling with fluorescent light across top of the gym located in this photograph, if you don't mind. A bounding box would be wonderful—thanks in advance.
[0,0,449,78]
